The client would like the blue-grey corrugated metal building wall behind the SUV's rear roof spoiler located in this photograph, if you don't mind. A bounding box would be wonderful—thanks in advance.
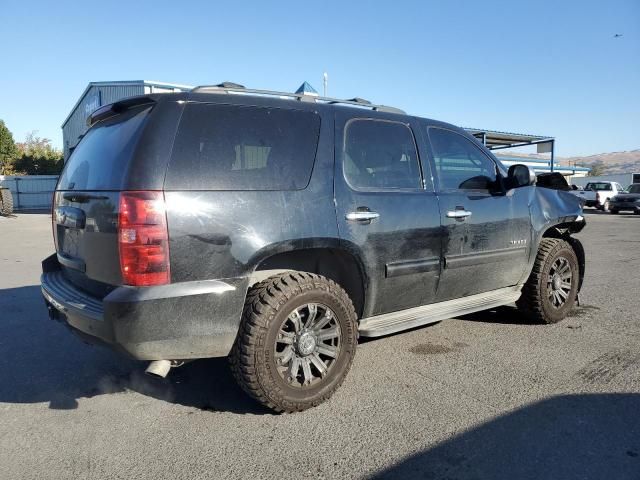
[62,83,145,160]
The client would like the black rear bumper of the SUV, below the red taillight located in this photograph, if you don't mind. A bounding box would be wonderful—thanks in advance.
[41,255,248,360]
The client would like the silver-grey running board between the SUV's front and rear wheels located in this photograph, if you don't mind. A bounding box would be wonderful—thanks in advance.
[358,286,522,337]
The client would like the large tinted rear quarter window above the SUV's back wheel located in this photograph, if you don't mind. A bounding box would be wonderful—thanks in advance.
[165,103,320,190]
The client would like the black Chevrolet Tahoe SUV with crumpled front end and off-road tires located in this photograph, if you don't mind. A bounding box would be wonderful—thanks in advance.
[42,84,585,412]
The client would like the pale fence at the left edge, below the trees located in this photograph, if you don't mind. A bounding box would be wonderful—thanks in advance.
[0,175,58,210]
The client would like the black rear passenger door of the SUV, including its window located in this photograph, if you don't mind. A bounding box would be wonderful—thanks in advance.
[335,112,441,317]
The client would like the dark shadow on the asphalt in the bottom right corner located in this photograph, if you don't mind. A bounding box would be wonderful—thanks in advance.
[372,393,640,480]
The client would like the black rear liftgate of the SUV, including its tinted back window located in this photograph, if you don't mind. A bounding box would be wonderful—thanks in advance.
[52,97,174,298]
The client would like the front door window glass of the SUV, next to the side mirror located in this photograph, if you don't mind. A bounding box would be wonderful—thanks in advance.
[428,127,497,190]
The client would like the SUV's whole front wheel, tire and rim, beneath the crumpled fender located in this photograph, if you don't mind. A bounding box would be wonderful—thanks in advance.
[516,238,580,323]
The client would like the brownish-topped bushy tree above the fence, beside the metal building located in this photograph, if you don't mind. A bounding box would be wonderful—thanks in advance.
[15,132,63,175]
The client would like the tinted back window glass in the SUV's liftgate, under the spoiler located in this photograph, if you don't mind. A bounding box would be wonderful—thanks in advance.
[58,107,151,190]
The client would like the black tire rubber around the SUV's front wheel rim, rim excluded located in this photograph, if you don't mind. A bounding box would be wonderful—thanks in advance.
[516,238,580,323]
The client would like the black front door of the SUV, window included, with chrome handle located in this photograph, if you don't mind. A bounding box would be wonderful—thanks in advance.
[427,126,533,301]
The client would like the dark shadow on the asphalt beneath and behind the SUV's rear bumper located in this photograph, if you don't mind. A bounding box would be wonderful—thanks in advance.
[0,285,271,415]
